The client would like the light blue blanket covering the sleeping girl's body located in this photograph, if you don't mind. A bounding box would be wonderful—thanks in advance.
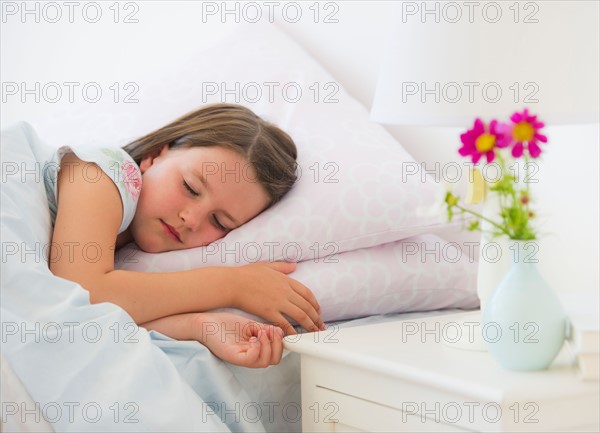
[1,123,301,432]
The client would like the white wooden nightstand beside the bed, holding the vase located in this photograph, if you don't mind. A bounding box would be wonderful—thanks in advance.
[284,313,600,432]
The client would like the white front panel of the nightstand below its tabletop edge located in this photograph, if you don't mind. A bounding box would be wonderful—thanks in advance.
[302,356,599,432]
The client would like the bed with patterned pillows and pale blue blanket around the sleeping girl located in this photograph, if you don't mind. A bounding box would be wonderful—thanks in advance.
[1,13,478,432]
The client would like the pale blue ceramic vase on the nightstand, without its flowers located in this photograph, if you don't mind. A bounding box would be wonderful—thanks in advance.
[482,241,567,370]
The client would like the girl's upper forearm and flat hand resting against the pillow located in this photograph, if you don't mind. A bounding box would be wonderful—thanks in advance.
[98,262,316,334]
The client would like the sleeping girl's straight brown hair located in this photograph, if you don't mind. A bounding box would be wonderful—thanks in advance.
[123,104,298,205]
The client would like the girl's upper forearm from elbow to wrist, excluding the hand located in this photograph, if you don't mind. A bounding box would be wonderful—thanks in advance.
[82,267,238,324]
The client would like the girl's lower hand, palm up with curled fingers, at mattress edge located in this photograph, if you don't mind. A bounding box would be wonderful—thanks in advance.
[192,312,283,368]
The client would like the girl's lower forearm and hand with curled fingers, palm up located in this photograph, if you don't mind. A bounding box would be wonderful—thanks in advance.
[140,312,283,368]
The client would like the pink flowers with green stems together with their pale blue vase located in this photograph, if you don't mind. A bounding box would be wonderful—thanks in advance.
[445,109,566,370]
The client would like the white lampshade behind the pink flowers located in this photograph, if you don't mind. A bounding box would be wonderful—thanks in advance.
[371,1,600,126]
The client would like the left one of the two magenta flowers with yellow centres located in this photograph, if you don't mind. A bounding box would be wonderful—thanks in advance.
[458,119,510,164]
